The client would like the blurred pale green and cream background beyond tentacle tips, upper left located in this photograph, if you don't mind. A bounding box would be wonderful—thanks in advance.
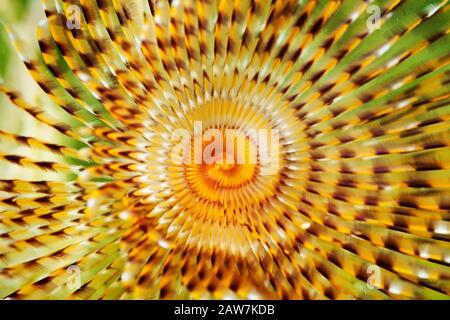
[0,0,60,179]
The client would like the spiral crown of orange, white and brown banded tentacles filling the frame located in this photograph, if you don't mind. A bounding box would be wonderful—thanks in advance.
[0,0,450,299]
